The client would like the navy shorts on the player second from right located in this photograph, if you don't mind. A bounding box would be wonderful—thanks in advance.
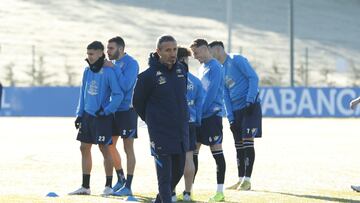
[196,114,223,146]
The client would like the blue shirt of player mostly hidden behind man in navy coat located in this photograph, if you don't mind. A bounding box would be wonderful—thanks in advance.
[186,72,205,125]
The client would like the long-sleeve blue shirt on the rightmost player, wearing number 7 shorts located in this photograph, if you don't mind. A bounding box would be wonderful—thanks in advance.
[223,55,259,122]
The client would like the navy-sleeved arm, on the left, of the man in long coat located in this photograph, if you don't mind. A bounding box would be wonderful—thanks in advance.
[133,71,152,121]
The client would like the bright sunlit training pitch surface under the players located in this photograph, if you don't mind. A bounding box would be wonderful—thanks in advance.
[0,118,360,202]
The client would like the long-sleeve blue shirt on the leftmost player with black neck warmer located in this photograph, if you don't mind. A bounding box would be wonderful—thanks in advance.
[76,67,124,117]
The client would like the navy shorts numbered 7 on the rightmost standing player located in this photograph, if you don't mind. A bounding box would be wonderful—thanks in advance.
[233,102,262,142]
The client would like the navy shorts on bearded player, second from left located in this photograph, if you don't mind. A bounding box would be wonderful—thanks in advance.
[113,108,138,138]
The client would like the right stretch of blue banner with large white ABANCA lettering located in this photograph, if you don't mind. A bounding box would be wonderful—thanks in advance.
[260,87,360,117]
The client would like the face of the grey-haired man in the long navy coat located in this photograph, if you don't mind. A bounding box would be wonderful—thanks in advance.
[156,41,177,66]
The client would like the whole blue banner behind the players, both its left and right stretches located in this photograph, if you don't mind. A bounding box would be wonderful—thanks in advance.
[0,87,360,117]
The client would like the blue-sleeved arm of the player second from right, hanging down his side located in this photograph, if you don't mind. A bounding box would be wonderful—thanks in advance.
[203,67,223,111]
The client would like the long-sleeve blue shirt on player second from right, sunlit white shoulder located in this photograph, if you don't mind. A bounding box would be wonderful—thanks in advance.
[199,58,224,118]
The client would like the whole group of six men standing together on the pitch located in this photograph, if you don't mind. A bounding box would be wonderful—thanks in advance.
[69,35,262,203]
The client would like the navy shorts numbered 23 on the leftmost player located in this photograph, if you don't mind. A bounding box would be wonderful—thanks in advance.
[76,112,113,145]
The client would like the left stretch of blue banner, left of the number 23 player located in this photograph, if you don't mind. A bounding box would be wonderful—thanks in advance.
[0,87,80,116]
